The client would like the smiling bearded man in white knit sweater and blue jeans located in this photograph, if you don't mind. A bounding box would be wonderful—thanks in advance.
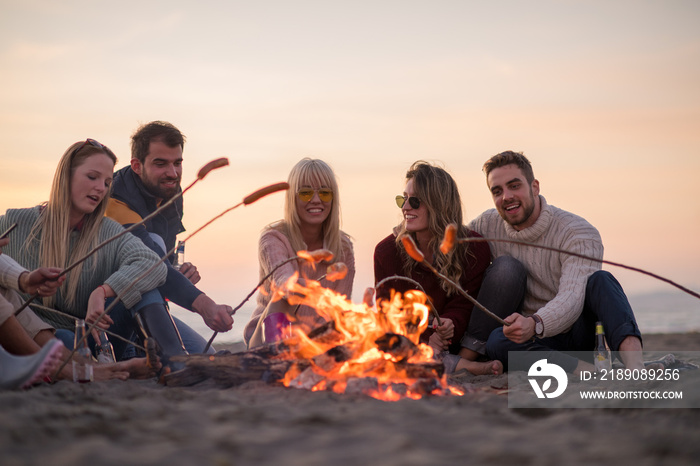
[461,151,644,373]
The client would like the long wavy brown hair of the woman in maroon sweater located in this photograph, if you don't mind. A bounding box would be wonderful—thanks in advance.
[396,160,473,295]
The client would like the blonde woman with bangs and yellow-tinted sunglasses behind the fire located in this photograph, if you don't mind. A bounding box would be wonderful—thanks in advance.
[244,158,355,348]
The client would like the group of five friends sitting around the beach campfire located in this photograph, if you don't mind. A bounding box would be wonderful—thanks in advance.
[0,121,644,388]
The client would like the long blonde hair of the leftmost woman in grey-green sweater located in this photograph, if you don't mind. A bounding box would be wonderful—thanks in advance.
[25,142,117,306]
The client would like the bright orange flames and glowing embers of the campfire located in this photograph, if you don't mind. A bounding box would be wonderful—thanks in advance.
[270,279,462,401]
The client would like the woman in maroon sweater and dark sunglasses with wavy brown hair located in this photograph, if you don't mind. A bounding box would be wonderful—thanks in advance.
[374,160,503,374]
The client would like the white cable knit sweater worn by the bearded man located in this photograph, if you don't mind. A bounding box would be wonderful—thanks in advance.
[469,196,603,337]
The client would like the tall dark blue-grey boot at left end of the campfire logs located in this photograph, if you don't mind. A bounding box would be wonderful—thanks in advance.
[136,303,188,372]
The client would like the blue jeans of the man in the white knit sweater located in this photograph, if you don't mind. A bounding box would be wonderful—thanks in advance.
[486,270,642,373]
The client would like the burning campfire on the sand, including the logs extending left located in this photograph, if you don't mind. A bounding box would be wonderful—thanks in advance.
[165,276,462,401]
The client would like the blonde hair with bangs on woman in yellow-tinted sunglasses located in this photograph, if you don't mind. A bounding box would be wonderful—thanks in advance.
[267,157,349,262]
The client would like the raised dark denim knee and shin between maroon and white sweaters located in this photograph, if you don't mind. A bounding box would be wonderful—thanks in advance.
[462,256,527,355]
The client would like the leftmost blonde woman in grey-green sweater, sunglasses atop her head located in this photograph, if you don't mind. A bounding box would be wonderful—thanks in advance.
[0,139,186,377]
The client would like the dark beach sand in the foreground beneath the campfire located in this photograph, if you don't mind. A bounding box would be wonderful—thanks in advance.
[0,333,700,466]
